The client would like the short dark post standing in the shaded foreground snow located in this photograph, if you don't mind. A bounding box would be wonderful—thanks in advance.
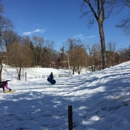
[68,106,73,130]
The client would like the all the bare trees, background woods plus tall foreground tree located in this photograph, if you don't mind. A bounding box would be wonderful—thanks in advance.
[0,0,130,81]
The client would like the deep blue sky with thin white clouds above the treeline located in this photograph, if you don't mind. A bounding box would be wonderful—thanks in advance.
[2,0,130,50]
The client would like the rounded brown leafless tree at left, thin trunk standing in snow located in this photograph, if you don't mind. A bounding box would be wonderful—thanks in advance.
[7,42,32,80]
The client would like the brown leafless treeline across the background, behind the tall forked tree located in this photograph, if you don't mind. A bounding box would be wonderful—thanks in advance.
[2,33,130,73]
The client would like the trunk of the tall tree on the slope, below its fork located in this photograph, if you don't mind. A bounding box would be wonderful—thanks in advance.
[98,20,107,69]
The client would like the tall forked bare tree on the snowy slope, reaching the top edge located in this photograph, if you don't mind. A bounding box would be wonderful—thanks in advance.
[83,0,117,69]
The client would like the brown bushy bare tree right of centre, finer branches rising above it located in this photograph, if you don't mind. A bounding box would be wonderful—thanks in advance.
[65,38,87,74]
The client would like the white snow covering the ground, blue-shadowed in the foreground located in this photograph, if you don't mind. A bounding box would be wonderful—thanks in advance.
[0,61,130,130]
